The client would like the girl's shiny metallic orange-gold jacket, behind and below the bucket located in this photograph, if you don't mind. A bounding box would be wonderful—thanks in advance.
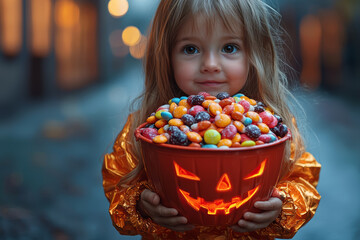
[102,115,321,240]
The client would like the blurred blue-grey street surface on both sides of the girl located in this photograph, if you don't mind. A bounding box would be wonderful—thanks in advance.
[0,61,360,240]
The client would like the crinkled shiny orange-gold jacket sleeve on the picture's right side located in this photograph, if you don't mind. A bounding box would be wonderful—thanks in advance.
[252,152,321,238]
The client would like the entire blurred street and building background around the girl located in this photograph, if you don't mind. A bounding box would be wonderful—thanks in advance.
[0,0,360,240]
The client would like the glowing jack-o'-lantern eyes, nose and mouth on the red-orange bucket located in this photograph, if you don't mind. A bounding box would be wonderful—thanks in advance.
[173,159,267,215]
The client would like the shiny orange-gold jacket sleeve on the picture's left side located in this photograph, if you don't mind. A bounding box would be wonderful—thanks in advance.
[102,115,169,235]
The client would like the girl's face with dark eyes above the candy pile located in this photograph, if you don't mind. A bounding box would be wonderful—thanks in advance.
[171,17,249,95]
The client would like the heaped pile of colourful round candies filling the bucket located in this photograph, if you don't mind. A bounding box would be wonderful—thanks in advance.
[140,92,288,148]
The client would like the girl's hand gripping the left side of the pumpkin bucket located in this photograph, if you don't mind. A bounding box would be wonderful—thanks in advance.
[138,189,194,232]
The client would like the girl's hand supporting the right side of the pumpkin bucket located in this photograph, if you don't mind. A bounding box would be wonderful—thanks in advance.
[231,197,282,232]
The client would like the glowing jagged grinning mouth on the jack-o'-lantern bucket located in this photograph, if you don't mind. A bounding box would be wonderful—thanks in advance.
[179,186,259,215]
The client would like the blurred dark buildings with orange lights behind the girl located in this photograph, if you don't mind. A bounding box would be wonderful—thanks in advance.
[0,0,360,116]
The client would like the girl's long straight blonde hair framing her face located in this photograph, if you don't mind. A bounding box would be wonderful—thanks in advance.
[126,0,304,184]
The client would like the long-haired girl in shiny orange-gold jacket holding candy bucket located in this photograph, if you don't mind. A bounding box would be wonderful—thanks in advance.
[102,0,320,239]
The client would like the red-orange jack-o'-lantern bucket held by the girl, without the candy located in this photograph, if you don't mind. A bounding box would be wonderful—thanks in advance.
[135,123,290,226]
